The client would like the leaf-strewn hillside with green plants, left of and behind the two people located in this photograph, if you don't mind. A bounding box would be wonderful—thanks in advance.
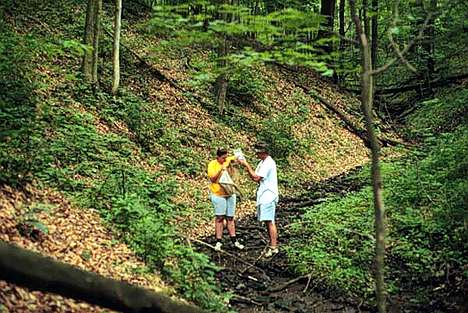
[0,0,367,312]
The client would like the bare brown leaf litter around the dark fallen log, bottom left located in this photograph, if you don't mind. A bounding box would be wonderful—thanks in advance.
[0,187,173,312]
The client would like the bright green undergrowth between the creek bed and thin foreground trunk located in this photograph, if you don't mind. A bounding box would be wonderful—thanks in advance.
[287,190,373,297]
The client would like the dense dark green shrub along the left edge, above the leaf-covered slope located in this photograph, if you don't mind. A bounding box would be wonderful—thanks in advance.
[0,20,67,186]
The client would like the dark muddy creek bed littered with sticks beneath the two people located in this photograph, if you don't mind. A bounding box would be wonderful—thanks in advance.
[194,169,371,313]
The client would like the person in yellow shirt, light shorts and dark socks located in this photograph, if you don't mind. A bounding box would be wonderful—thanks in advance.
[207,148,244,251]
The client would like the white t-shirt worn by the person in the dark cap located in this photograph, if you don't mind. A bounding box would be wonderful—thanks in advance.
[255,156,279,205]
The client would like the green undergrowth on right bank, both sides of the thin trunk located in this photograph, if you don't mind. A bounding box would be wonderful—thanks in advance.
[287,125,468,303]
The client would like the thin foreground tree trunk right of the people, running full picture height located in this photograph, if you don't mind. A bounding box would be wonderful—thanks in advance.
[349,0,386,313]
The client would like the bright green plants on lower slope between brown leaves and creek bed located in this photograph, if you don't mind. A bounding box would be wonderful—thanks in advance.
[88,171,229,311]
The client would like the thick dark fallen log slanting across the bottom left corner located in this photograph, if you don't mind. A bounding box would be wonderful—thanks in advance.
[0,241,202,313]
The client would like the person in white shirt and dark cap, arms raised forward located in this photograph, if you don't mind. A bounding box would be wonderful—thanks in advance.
[238,143,279,257]
